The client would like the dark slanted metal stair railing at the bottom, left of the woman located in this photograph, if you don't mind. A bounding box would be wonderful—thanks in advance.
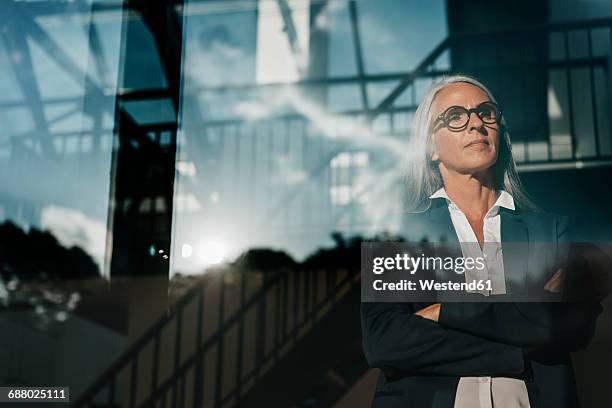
[73,270,360,407]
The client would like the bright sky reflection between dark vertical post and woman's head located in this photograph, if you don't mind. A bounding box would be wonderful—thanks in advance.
[173,0,445,273]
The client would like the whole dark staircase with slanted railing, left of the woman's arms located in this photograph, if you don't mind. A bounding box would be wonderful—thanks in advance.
[73,268,367,407]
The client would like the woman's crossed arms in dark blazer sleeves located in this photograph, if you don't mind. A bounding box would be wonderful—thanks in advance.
[361,272,601,376]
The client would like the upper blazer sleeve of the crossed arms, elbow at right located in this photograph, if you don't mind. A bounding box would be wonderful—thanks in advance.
[438,217,602,351]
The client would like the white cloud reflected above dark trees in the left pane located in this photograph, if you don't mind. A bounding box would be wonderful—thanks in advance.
[40,205,106,271]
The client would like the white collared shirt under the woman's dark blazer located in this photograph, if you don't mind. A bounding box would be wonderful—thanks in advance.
[429,188,530,408]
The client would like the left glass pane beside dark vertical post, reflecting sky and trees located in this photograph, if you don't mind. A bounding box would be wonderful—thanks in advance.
[0,0,125,397]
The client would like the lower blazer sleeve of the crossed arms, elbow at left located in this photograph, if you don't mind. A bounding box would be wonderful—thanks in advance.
[361,303,525,376]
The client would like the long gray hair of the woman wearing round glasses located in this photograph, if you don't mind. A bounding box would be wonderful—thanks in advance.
[406,75,536,212]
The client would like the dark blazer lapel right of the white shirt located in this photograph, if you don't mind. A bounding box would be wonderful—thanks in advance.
[500,208,529,295]
